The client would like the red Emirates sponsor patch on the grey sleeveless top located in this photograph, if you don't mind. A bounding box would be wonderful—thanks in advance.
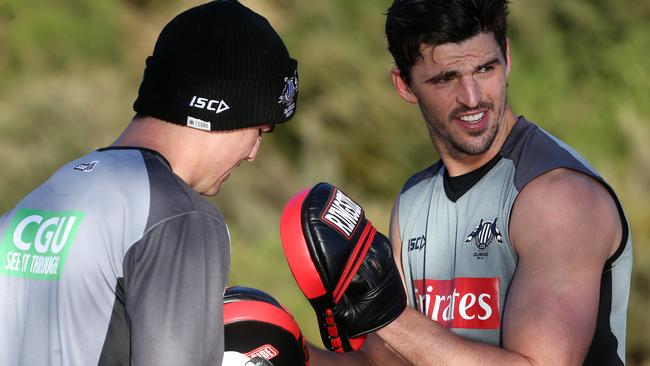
[413,278,500,329]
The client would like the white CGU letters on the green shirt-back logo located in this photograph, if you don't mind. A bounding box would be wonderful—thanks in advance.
[13,215,77,254]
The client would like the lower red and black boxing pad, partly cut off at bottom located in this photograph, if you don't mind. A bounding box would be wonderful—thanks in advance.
[223,286,309,366]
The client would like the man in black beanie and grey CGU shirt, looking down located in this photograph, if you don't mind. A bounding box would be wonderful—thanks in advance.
[0,0,298,365]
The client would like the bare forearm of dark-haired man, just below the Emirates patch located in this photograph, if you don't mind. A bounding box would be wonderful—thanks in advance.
[377,308,532,366]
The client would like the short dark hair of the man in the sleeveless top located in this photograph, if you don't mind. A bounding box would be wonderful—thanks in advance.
[386,0,509,82]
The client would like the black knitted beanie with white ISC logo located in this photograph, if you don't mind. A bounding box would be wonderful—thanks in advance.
[133,0,298,131]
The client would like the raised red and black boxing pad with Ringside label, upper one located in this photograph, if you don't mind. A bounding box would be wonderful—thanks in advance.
[280,183,406,352]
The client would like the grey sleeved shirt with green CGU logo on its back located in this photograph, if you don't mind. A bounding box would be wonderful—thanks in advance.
[0,148,230,366]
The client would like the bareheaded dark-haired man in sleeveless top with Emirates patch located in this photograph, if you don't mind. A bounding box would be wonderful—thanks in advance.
[310,0,632,365]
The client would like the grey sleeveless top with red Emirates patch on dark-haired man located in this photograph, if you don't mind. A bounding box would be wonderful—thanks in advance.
[398,117,632,365]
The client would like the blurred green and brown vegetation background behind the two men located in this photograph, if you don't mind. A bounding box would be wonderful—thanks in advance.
[0,0,650,365]
